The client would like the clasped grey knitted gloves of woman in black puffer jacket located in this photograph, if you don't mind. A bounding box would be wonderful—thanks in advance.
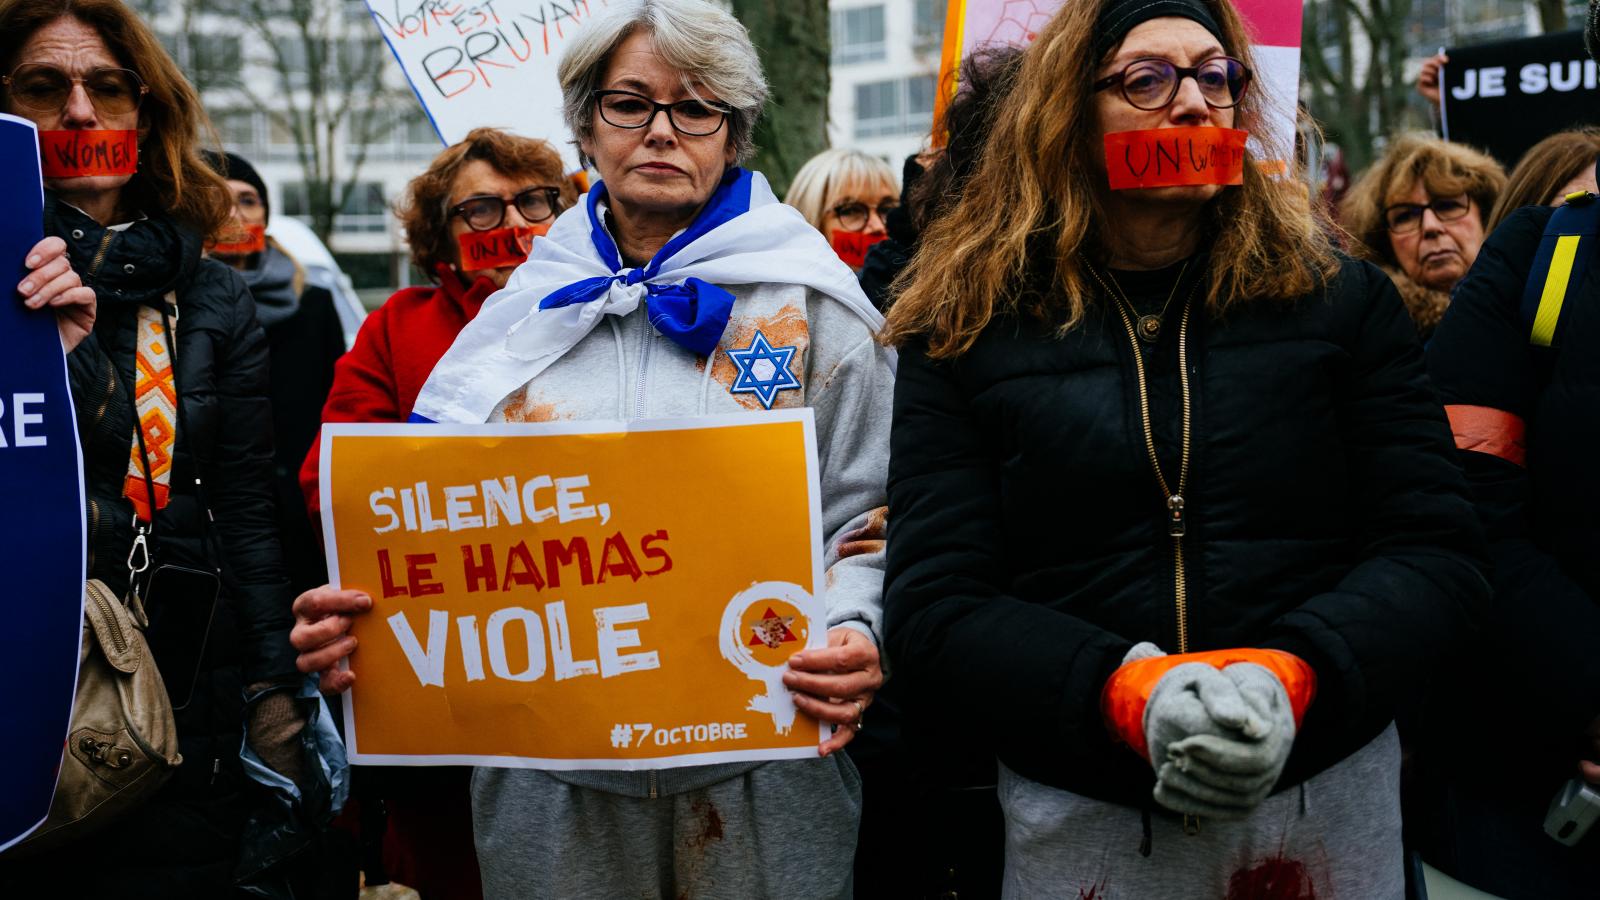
[1146,663,1294,818]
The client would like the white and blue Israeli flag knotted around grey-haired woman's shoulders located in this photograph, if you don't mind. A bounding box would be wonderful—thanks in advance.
[411,168,883,423]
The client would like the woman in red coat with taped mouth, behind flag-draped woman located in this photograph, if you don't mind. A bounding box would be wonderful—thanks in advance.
[301,128,578,900]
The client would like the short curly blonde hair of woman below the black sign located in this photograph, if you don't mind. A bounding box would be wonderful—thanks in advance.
[1339,131,1506,266]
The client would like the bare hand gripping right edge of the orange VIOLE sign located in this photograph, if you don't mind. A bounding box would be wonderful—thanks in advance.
[784,628,883,756]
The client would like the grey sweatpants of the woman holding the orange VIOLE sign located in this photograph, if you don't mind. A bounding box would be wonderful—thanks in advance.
[472,753,861,900]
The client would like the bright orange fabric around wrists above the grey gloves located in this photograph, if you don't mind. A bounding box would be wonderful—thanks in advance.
[1101,647,1317,759]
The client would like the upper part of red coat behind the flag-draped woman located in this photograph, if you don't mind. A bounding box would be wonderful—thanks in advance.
[301,266,496,512]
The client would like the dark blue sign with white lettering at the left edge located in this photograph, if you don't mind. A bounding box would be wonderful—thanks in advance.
[0,115,86,850]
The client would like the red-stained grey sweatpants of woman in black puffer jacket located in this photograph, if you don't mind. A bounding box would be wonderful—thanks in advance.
[1000,725,1405,900]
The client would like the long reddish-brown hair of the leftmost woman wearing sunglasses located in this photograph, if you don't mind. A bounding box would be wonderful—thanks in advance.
[0,0,234,237]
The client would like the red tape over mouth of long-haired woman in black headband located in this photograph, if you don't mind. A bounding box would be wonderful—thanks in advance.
[1106,127,1250,191]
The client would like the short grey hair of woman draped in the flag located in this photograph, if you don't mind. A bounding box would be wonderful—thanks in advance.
[557,0,766,163]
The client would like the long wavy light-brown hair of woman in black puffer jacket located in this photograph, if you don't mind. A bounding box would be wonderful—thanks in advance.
[880,0,1338,359]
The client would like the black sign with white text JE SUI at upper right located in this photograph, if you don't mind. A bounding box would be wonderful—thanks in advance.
[1440,30,1600,168]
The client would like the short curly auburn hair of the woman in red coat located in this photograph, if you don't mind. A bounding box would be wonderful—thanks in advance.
[395,128,578,280]
